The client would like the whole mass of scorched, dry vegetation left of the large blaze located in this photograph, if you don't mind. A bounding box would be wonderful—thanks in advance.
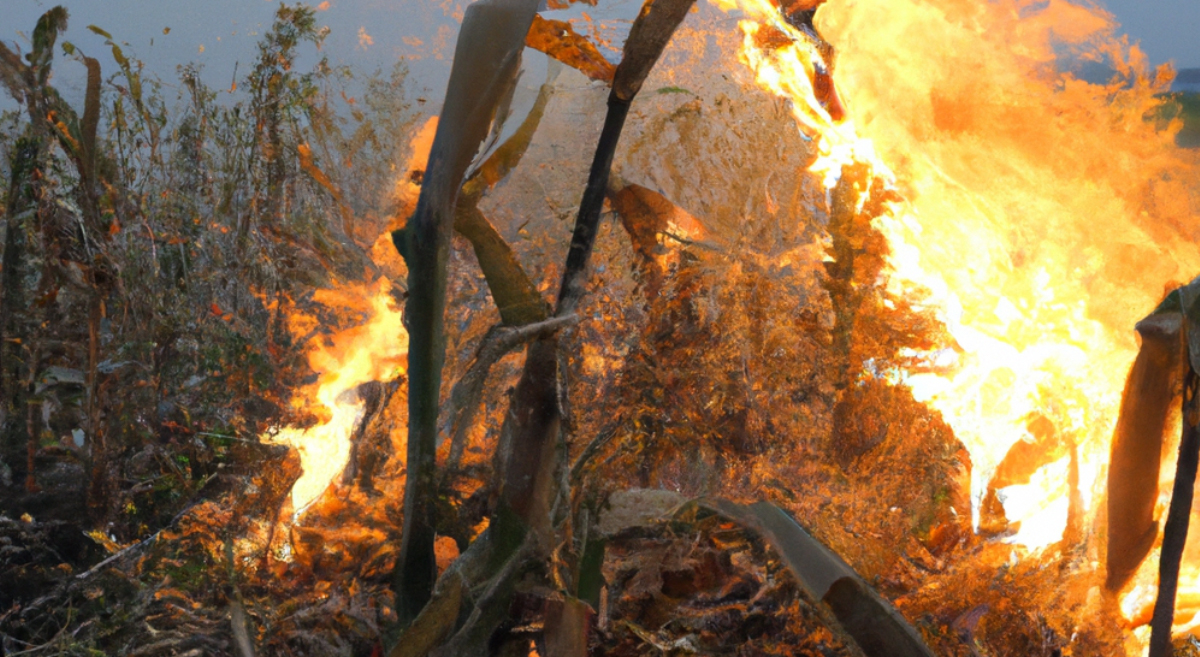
[0,0,1152,657]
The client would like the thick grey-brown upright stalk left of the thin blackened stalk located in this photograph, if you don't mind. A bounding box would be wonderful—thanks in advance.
[392,0,536,622]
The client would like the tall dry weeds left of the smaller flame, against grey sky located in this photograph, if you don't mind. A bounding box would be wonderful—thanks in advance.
[0,6,415,541]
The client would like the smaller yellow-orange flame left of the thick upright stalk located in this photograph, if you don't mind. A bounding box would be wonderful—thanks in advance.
[264,277,408,513]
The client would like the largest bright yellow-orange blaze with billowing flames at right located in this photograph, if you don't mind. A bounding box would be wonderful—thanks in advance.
[718,0,1200,623]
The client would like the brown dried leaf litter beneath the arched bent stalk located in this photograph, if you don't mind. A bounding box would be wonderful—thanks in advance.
[589,517,860,657]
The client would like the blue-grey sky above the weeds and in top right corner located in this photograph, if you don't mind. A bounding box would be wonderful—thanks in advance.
[0,0,1200,107]
